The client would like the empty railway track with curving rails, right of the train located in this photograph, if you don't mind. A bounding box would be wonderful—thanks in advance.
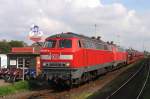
[106,60,150,99]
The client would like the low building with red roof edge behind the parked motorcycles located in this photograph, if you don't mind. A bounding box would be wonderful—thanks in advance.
[7,43,40,72]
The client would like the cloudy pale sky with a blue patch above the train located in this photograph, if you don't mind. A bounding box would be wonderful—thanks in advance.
[0,0,150,51]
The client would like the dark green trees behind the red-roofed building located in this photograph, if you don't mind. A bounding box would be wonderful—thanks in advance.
[0,40,27,53]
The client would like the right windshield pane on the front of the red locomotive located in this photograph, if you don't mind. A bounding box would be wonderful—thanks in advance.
[59,39,72,48]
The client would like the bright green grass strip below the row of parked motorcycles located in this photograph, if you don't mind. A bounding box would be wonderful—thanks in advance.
[0,81,30,96]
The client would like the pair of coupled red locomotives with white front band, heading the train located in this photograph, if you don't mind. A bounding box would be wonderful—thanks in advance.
[40,32,144,84]
